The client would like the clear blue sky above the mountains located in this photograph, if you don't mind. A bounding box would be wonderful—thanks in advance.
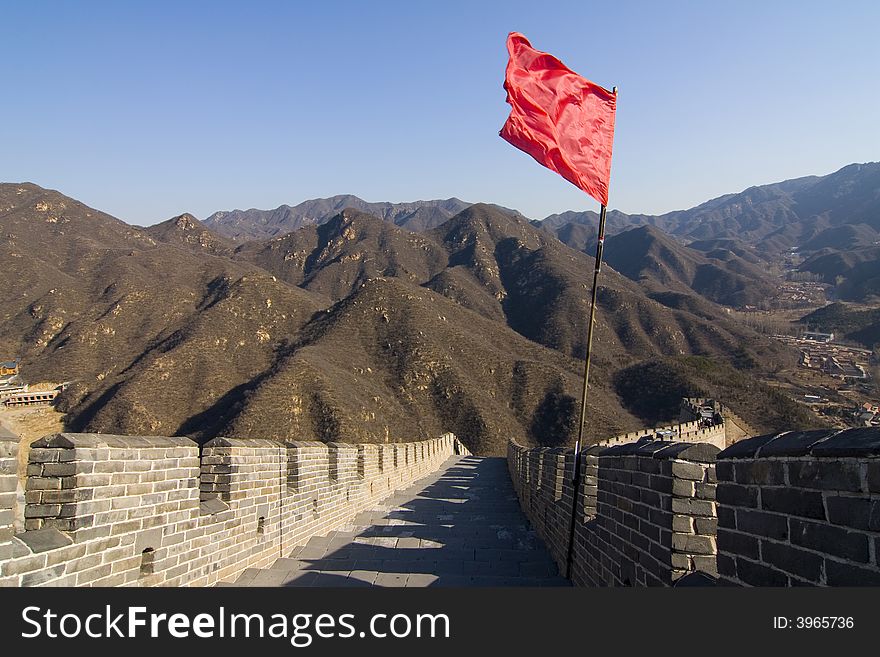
[0,0,880,225]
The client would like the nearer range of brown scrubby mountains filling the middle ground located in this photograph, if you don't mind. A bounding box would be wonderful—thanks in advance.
[0,183,820,453]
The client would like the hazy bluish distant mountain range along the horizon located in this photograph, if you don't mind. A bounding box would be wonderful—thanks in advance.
[205,163,880,307]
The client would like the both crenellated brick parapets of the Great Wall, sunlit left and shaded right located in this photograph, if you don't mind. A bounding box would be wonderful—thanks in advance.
[0,400,880,586]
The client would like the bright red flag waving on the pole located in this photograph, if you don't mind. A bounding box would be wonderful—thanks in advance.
[501,32,617,205]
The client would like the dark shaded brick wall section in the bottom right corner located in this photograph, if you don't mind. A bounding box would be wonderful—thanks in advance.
[717,428,880,586]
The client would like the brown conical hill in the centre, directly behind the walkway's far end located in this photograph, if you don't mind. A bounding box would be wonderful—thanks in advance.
[203,278,639,453]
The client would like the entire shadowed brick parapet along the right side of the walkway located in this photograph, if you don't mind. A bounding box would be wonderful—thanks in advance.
[508,428,880,586]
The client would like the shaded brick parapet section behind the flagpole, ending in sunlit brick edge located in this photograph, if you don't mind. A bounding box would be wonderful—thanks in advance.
[508,440,718,586]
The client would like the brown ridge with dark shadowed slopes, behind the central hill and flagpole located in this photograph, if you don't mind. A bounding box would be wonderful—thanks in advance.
[427,204,778,366]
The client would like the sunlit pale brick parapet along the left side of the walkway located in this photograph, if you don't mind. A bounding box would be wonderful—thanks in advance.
[0,434,467,586]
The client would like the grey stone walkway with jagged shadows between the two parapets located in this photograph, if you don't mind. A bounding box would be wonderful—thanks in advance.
[220,456,569,587]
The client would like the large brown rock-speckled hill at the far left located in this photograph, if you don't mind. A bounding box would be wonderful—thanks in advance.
[0,185,321,434]
